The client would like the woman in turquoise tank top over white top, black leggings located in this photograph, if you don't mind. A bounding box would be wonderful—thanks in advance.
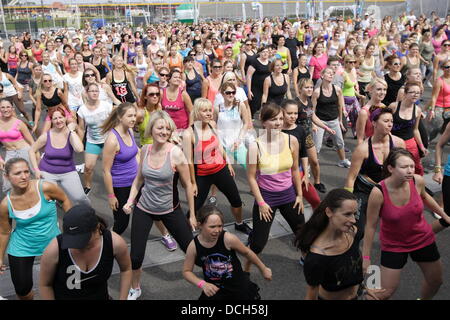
[0,158,72,300]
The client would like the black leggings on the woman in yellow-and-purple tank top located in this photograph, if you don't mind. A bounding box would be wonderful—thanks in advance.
[248,202,305,254]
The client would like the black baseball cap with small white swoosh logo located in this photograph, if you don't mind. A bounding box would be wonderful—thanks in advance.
[61,204,98,249]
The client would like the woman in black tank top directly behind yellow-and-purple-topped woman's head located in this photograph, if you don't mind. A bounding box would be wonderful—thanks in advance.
[261,59,292,105]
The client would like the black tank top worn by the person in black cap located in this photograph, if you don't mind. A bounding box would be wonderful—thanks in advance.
[53,229,114,300]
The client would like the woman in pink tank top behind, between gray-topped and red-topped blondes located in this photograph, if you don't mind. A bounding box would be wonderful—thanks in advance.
[161,70,192,130]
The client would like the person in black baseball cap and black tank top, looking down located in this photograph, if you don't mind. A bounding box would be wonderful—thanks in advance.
[40,205,131,300]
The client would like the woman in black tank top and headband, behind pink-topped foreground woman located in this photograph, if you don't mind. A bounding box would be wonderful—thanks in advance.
[345,108,405,235]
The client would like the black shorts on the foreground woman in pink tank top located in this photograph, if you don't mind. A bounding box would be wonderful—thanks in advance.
[381,242,441,269]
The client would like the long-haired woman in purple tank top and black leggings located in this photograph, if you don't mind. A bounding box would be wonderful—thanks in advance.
[102,102,139,234]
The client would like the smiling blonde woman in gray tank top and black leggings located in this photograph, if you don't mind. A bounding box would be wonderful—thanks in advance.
[123,111,197,300]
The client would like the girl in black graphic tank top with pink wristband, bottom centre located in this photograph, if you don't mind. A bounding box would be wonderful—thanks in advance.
[183,205,272,300]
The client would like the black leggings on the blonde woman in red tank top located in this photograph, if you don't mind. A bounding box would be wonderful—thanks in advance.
[195,166,242,211]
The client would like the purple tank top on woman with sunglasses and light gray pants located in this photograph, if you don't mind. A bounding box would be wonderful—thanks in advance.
[39,130,75,174]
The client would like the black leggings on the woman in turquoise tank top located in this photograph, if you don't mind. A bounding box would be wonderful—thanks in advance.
[8,254,35,297]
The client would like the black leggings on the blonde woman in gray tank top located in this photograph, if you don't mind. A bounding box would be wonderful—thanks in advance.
[130,206,194,270]
